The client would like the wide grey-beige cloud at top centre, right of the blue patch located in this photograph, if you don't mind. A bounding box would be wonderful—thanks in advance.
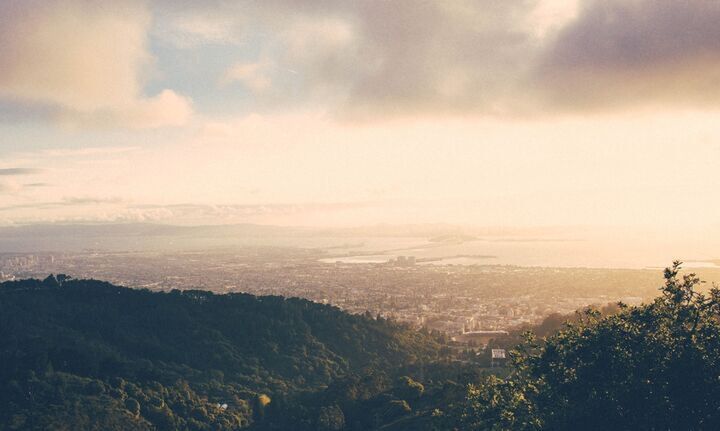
[161,0,544,118]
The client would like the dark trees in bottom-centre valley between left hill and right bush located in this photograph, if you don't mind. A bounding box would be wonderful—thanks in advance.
[255,361,480,431]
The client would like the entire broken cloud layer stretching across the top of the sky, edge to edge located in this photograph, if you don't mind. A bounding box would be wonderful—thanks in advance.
[7,0,720,128]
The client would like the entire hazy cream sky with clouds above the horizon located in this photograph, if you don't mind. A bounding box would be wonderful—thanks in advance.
[0,0,720,229]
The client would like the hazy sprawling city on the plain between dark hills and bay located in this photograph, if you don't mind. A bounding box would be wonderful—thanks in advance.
[0,247,684,335]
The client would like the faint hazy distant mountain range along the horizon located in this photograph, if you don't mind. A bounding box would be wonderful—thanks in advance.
[0,223,580,253]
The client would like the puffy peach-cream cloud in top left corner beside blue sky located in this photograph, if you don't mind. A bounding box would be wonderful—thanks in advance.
[0,0,191,127]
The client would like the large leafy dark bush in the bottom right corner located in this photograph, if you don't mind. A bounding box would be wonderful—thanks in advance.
[464,262,720,430]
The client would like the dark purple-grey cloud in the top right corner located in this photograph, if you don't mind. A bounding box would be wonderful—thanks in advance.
[532,0,720,111]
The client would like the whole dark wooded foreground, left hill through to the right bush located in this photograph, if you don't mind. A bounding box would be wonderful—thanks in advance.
[0,262,708,431]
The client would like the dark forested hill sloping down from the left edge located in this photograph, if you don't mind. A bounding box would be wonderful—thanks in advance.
[0,277,439,429]
